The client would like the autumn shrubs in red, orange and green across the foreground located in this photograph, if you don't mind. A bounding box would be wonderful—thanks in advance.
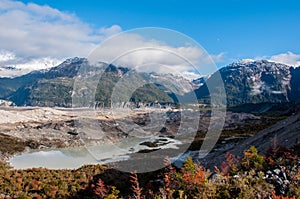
[0,143,300,199]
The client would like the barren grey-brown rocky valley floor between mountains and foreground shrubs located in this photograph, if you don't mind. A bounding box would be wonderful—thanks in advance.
[0,104,300,166]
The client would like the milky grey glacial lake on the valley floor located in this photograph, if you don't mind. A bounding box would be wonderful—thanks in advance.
[9,137,181,169]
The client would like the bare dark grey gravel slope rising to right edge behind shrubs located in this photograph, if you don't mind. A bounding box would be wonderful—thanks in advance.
[199,105,300,168]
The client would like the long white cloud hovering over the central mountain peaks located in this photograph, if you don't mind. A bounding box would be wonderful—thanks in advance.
[89,33,224,74]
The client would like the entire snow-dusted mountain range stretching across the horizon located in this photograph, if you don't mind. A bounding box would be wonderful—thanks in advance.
[0,58,300,107]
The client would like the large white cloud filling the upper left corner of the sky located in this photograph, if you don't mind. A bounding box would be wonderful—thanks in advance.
[0,0,121,68]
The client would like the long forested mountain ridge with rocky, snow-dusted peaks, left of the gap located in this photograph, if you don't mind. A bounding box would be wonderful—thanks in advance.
[0,58,191,107]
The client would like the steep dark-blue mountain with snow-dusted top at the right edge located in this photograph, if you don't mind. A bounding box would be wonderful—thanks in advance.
[195,60,300,106]
